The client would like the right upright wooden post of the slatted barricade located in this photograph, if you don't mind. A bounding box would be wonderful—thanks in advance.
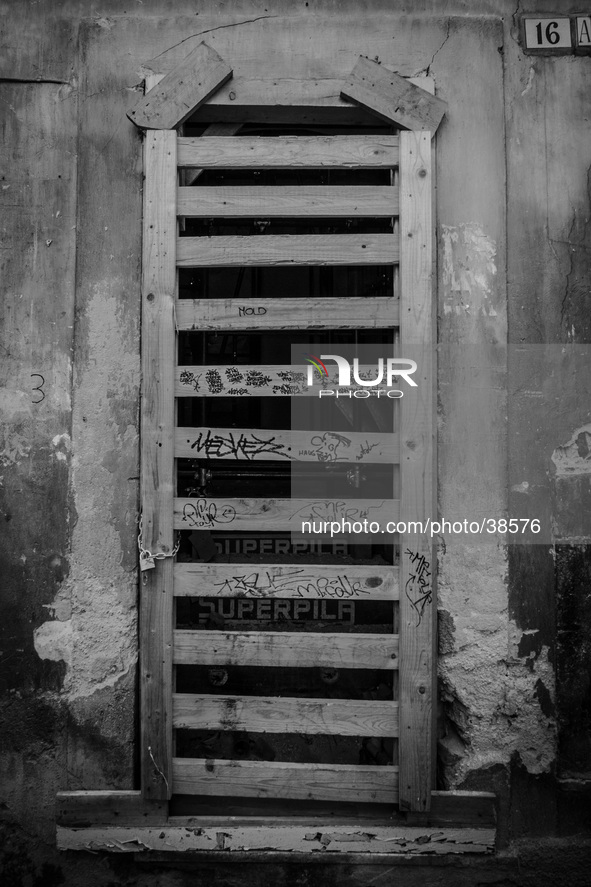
[399,132,435,811]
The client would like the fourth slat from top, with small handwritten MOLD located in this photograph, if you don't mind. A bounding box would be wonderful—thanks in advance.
[176,296,400,331]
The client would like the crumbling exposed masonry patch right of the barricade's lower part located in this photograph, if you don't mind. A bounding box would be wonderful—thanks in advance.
[438,545,556,788]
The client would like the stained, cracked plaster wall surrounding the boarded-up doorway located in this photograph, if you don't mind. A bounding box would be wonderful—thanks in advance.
[0,0,591,885]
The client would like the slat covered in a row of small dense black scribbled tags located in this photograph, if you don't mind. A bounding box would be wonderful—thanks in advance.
[174,364,408,405]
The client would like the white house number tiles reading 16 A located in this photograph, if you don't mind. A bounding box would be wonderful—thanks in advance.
[521,13,591,55]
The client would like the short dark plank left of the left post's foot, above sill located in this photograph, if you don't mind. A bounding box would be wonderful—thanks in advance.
[56,791,168,828]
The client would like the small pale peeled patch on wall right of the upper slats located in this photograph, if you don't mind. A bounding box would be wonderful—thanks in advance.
[441,222,497,317]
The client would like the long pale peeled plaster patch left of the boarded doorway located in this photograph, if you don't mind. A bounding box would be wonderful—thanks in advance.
[34,290,139,701]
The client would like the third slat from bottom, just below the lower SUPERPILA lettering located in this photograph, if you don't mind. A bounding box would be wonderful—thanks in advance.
[173,629,398,670]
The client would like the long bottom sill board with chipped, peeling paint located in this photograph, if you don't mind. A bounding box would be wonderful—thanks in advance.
[57,824,498,856]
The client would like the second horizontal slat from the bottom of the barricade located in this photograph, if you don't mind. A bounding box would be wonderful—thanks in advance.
[172,693,398,736]
